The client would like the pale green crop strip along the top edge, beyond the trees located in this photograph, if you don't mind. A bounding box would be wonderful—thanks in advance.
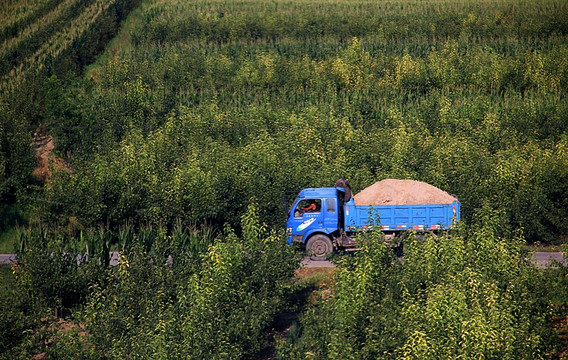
[133,0,568,44]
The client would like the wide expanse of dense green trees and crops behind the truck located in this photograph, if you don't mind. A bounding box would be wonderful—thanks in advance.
[0,0,568,243]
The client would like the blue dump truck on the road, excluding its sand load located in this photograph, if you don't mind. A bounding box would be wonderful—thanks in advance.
[286,183,460,260]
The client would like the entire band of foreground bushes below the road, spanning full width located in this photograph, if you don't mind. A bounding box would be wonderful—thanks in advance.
[4,208,568,359]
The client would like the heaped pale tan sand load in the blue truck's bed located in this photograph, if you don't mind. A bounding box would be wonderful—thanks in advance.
[354,179,457,206]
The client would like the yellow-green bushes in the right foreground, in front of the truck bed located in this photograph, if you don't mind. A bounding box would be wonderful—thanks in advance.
[280,212,566,359]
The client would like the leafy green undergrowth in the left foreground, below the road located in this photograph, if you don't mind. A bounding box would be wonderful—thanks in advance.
[0,206,299,359]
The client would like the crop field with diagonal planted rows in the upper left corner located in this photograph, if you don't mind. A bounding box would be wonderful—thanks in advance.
[0,0,141,91]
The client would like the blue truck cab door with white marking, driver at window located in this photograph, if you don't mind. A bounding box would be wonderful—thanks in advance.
[291,199,325,240]
